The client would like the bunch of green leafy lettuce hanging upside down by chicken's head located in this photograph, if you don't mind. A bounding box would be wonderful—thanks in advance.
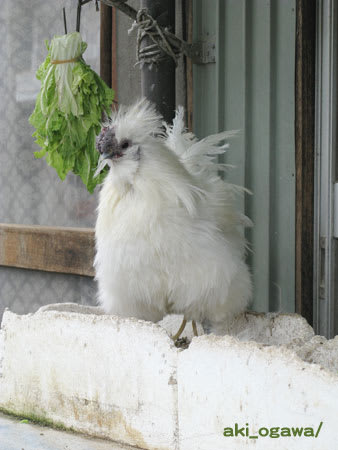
[29,32,114,192]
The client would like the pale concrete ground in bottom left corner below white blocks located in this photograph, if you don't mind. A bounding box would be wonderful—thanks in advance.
[0,413,135,450]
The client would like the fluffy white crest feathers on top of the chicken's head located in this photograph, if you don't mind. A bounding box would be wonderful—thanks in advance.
[104,98,162,143]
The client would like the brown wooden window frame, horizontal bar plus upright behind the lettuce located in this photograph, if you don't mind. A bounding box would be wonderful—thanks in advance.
[0,3,117,277]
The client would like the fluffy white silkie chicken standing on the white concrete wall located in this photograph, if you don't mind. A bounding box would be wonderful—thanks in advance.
[95,99,251,339]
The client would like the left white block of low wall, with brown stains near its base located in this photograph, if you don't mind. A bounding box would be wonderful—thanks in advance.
[0,311,177,449]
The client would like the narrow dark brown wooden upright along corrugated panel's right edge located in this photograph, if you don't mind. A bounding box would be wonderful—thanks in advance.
[295,0,316,325]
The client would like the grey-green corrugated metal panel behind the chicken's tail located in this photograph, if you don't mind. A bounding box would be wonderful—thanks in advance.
[193,0,295,312]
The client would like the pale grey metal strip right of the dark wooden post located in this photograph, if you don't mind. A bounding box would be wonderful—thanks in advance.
[314,0,338,338]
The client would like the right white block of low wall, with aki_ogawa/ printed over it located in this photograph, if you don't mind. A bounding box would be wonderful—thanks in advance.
[177,336,338,450]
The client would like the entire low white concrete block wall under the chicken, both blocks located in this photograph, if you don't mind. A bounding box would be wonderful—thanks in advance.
[0,304,338,450]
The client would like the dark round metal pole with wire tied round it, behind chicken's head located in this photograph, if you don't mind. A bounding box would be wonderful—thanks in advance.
[141,0,175,122]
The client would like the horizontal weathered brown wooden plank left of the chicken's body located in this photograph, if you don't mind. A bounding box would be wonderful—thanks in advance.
[0,224,95,277]
